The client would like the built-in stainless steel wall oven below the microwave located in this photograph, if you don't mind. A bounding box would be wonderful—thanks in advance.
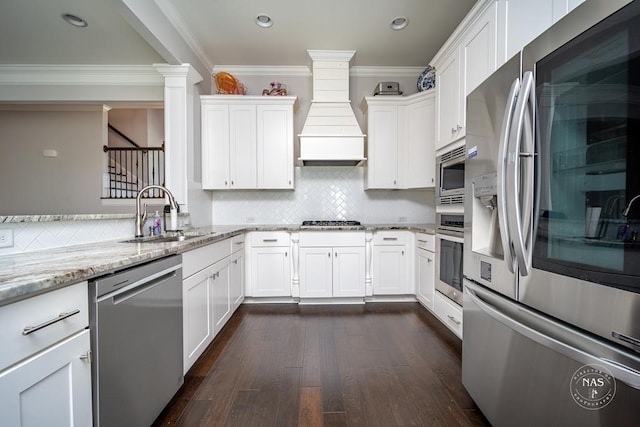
[436,213,464,306]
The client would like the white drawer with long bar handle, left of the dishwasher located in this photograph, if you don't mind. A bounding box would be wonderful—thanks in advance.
[0,282,89,370]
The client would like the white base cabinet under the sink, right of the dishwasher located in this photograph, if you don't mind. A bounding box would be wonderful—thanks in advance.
[182,235,245,373]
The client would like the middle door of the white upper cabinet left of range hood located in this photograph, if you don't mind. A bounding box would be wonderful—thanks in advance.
[229,105,258,189]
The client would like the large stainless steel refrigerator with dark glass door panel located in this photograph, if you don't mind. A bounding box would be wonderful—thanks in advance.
[462,0,640,426]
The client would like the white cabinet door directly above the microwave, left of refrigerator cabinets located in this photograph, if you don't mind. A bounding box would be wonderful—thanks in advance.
[436,49,461,150]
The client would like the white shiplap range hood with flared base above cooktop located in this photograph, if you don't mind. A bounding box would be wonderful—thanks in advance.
[298,50,366,166]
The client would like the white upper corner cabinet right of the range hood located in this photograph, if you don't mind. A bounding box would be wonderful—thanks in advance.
[360,90,435,189]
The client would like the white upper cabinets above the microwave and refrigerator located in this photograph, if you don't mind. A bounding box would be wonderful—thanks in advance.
[431,0,584,154]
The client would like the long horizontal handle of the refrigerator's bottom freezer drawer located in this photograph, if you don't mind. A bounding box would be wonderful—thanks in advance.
[465,283,640,390]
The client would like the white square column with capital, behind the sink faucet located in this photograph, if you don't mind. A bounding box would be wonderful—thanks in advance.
[154,64,202,212]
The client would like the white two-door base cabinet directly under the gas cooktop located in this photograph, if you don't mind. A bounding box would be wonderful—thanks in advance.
[299,231,365,299]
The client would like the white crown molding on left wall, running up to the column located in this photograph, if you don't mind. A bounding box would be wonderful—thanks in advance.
[0,64,164,86]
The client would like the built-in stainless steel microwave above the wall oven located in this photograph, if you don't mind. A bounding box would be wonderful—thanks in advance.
[436,145,465,206]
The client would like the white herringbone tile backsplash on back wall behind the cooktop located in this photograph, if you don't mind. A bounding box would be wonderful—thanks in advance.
[212,166,435,225]
